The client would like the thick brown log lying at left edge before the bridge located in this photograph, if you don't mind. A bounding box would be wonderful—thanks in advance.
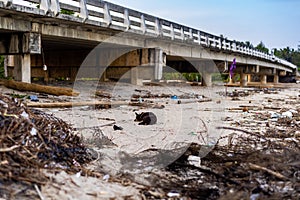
[0,80,79,96]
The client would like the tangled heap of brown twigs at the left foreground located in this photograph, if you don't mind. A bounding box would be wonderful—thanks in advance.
[0,94,94,198]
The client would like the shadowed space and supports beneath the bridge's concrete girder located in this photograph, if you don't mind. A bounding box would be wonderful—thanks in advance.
[1,36,292,86]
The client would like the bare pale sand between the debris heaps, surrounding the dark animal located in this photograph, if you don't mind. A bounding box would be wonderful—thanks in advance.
[0,82,300,199]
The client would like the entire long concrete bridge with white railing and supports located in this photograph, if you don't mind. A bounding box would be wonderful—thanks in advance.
[0,0,297,86]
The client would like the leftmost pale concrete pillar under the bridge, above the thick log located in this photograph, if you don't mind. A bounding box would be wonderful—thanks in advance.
[14,54,31,83]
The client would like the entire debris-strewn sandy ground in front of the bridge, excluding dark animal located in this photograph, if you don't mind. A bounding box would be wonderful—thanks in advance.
[0,82,300,200]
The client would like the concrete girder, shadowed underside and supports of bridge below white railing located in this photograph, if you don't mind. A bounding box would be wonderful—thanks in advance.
[0,15,292,86]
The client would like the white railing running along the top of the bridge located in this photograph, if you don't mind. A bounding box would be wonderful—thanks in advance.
[1,0,297,69]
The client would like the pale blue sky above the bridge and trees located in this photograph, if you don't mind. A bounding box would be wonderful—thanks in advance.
[106,0,300,50]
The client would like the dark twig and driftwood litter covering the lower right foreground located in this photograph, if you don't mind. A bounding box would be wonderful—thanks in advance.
[139,125,300,200]
